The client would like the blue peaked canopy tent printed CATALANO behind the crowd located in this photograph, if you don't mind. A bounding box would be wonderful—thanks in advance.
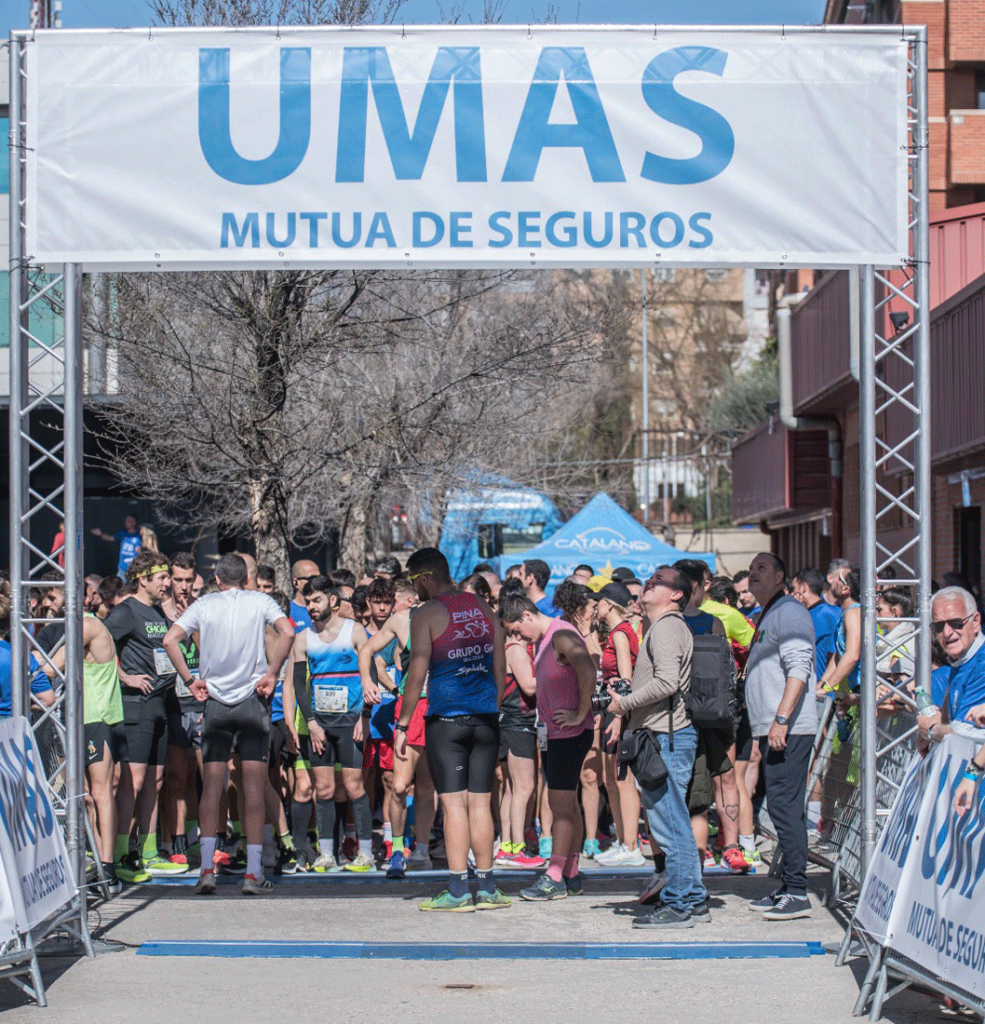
[500,495,715,595]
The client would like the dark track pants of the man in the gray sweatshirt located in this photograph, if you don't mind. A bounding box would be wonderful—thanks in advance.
[760,735,814,896]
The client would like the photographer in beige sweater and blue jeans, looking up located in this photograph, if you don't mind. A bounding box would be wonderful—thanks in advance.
[609,565,712,929]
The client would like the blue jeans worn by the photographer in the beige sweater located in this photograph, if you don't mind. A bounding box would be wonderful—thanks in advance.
[640,725,708,911]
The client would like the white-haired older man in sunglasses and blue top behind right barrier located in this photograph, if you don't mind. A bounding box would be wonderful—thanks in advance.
[917,587,985,750]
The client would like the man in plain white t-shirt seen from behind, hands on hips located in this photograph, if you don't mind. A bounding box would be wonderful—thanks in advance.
[164,554,294,896]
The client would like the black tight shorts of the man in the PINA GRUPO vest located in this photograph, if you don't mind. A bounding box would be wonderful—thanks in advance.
[424,715,500,794]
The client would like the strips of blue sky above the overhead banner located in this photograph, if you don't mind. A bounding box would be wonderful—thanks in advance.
[0,0,824,39]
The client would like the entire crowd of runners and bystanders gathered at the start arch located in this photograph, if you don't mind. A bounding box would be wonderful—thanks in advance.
[0,520,985,928]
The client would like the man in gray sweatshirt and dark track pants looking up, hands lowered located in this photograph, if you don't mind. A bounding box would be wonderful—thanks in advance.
[745,552,817,921]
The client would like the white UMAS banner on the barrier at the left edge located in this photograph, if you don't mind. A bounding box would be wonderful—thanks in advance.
[0,718,75,932]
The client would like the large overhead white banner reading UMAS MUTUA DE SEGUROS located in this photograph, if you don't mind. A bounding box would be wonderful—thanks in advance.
[27,26,908,269]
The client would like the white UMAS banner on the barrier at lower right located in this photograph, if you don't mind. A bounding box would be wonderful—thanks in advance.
[855,728,985,996]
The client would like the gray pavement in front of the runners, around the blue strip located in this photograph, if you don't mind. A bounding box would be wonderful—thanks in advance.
[0,874,956,1024]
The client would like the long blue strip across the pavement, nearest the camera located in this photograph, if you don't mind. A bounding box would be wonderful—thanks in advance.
[137,941,824,961]
